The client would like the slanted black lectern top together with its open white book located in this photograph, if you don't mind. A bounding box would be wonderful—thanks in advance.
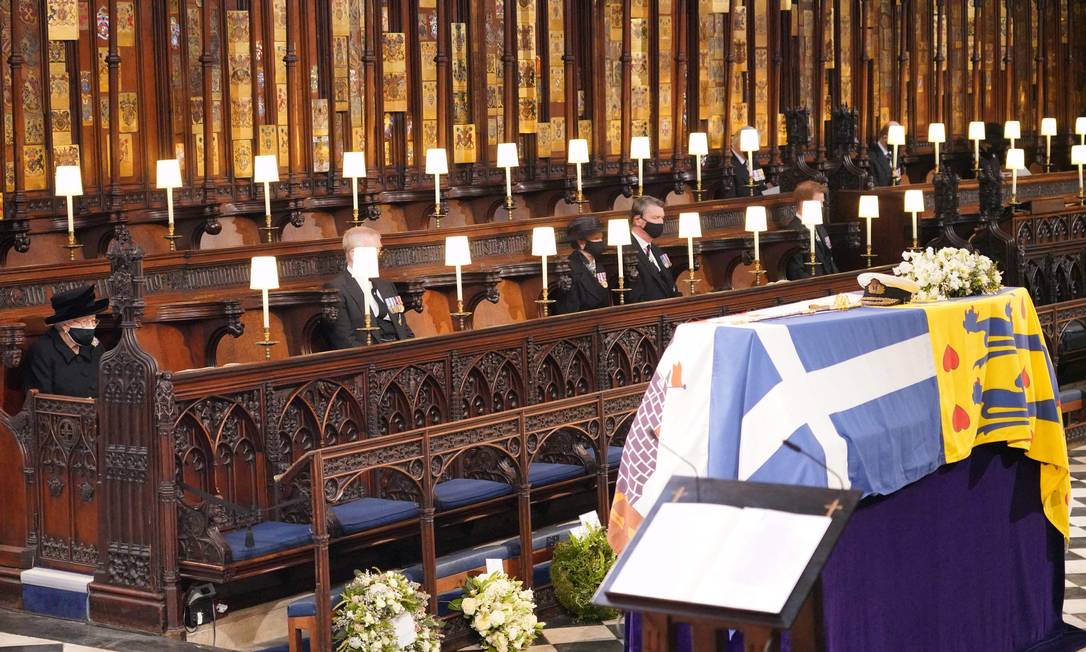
[596,477,860,627]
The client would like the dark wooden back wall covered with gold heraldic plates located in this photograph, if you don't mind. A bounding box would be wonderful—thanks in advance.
[0,0,1086,265]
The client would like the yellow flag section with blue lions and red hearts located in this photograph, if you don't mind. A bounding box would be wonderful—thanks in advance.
[913,288,1071,538]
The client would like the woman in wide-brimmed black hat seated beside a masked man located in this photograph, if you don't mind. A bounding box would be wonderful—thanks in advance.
[554,215,611,315]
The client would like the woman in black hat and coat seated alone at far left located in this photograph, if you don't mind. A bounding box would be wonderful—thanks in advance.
[24,286,110,399]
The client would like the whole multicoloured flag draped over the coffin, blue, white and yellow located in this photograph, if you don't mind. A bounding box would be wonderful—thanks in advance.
[609,288,1071,550]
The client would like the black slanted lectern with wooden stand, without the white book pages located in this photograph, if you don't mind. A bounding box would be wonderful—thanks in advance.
[594,477,860,652]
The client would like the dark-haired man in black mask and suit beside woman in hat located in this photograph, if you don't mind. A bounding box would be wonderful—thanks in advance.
[627,196,681,303]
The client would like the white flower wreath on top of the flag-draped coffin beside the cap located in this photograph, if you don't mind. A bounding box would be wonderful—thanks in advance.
[894,247,1003,301]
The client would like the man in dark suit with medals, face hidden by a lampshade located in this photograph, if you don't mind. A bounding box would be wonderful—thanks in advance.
[325,226,415,349]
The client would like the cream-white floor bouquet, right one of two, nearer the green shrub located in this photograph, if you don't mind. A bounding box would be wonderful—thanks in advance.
[449,572,543,652]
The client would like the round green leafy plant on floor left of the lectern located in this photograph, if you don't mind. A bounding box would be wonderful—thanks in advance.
[551,527,619,623]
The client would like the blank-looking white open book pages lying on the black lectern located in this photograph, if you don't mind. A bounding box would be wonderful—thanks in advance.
[610,503,831,613]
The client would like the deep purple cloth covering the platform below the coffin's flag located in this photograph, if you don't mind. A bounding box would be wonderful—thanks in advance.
[626,444,1086,652]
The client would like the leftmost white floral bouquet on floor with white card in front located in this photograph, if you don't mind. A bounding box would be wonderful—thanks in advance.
[332,571,441,652]
